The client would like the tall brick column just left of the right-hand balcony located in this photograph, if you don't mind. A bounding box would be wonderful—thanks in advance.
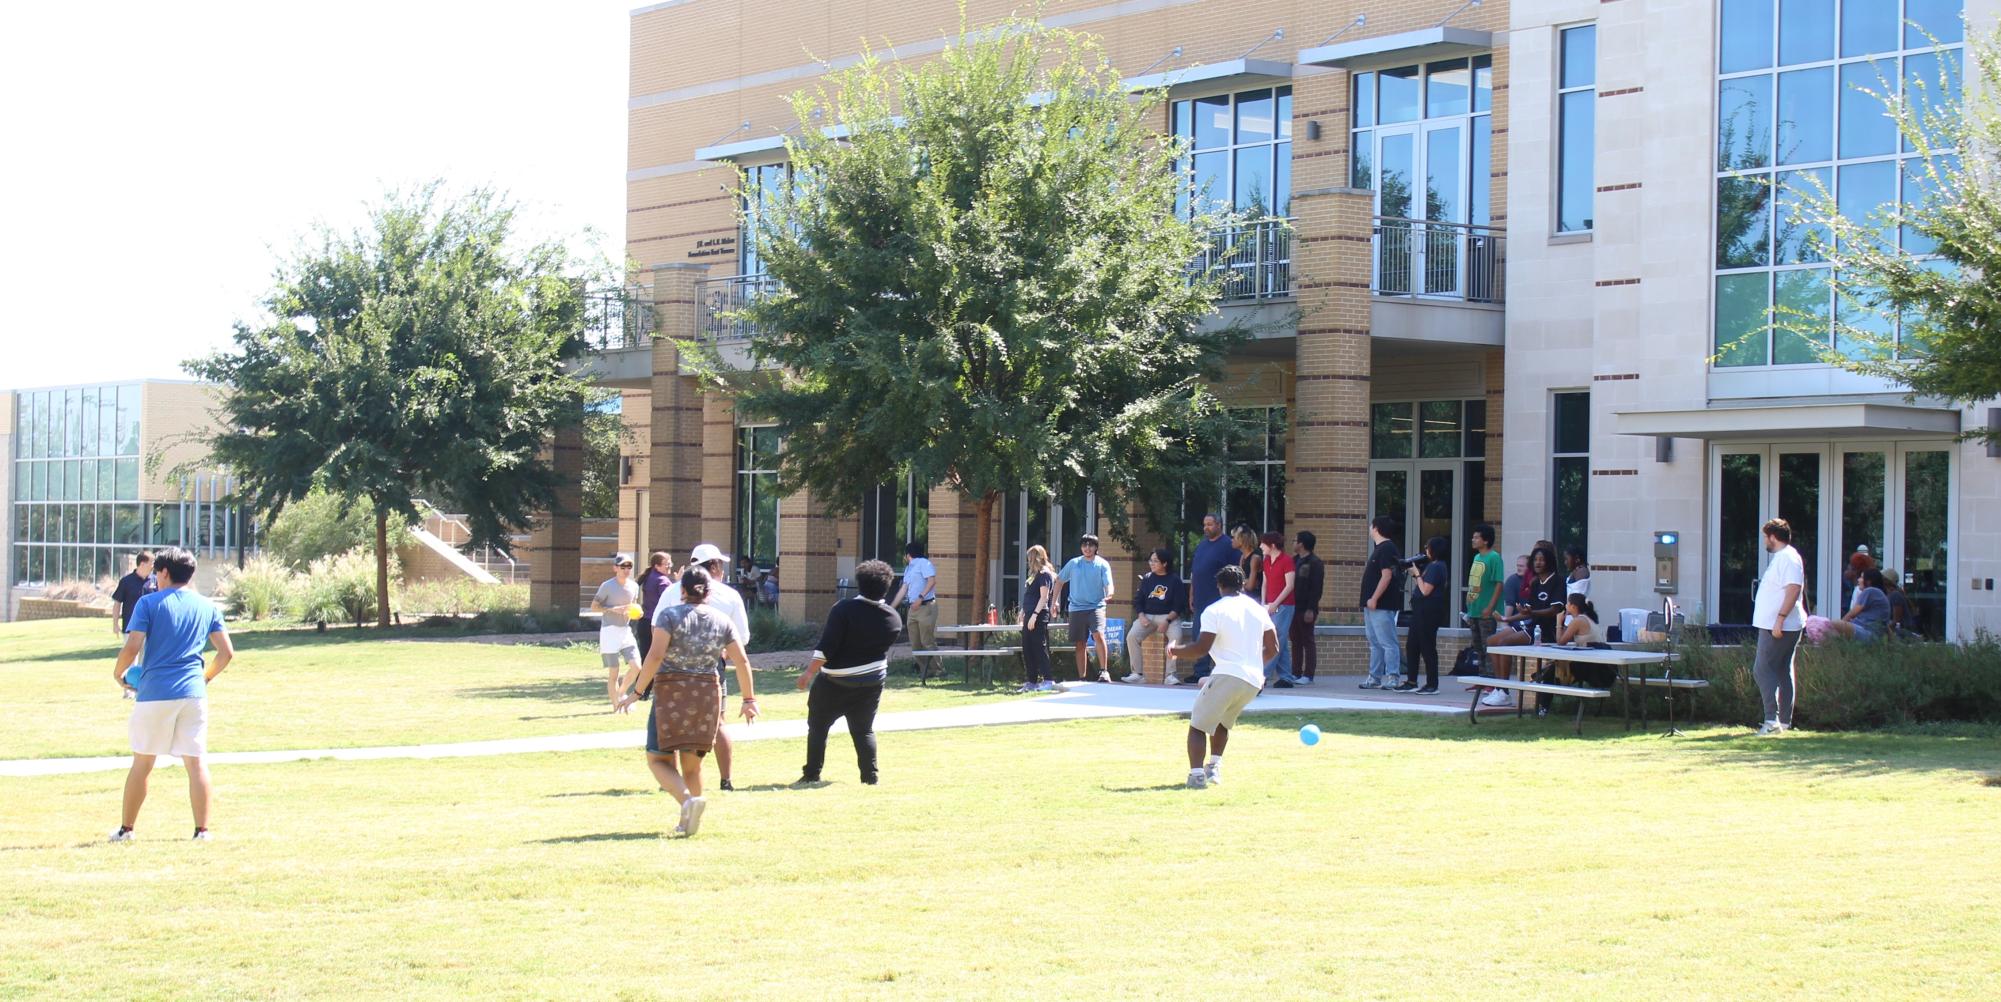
[1287,74,1375,624]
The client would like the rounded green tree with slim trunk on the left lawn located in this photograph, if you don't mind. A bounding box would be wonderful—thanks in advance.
[188,182,584,626]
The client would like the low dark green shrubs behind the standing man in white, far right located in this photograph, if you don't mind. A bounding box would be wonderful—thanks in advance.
[1677,628,2001,730]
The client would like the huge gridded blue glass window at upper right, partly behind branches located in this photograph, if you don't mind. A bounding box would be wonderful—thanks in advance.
[1715,0,1965,366]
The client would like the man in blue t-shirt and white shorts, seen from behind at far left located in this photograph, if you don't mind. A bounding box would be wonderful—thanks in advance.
[112,546,236,842]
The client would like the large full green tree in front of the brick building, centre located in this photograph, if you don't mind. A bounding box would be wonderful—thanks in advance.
[710,20,1245,608]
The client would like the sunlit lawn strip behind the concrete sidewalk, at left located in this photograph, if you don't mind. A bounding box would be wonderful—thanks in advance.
[0,620,1007,758]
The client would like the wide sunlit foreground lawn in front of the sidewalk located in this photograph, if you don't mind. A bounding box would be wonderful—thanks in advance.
[0,714,2001,1000]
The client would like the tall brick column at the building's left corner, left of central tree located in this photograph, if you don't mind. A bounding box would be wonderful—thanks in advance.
[644,262,722,560]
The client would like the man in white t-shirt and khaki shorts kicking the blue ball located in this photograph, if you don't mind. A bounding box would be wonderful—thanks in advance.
[1167,564,1279,790]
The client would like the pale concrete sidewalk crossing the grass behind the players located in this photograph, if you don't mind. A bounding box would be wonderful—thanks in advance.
[0,682,1465,776]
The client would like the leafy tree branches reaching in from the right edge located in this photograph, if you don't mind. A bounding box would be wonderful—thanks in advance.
[1775,30,2001,438]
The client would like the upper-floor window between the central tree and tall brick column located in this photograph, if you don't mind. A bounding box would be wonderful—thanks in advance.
[1173,86,1293,218]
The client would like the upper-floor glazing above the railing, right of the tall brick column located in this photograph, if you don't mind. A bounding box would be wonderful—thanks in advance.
[1349,56,1495,224]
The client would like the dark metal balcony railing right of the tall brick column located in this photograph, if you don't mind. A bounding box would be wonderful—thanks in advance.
[1369,216,1507,304]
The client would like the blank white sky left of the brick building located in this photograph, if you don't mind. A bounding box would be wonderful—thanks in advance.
[0,0,638,388]
